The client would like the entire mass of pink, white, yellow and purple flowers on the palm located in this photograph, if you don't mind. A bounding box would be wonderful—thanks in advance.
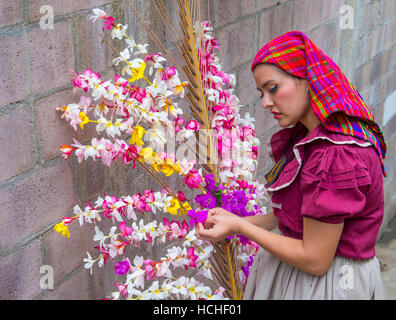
[54,9,265,299]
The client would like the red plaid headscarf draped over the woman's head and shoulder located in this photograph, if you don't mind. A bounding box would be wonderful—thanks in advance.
[252,31,386,176]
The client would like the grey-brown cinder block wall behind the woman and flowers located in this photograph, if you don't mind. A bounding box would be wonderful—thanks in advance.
[0,0,396,299]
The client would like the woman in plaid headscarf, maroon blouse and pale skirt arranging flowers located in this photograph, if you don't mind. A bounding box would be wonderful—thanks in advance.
[196,32,386,299]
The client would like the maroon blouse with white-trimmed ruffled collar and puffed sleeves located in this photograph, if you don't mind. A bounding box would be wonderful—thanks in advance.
[266,124,384,259]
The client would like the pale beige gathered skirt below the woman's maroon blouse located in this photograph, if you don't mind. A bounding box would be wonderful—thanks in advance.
[243,228,386,300]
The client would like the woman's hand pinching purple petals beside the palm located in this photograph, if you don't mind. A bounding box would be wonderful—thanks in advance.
[195,208,243,241]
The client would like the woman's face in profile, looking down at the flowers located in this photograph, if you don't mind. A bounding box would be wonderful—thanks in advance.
[253,64,313,127]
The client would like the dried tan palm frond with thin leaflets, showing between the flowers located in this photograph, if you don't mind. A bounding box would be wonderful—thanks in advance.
[126,0,242,300]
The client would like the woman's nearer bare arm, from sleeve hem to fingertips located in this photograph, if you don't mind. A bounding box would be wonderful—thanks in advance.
[197,209,344,276]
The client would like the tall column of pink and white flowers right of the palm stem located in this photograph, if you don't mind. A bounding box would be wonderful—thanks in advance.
[195,22,260,187]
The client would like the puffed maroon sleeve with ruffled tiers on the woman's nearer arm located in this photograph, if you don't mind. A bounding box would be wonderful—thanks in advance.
[300,144,371,223]
